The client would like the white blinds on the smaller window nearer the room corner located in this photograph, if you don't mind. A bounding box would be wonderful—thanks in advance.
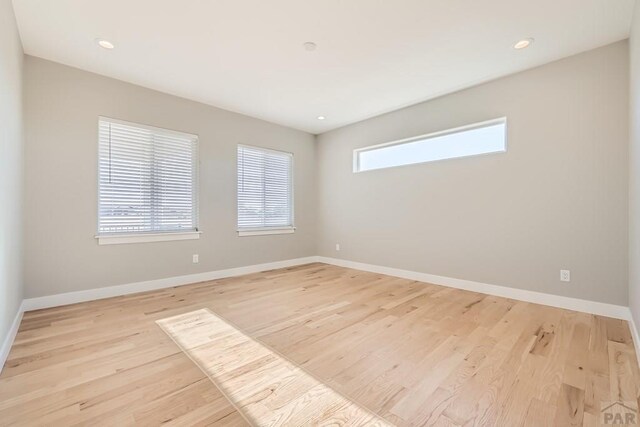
[238,145,293,231]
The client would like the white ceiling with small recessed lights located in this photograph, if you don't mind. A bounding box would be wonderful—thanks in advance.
[13,0,634,133]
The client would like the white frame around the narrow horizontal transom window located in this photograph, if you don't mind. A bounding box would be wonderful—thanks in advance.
[353,116,508,173]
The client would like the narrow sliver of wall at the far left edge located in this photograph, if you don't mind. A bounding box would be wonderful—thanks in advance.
[0,0,23,344]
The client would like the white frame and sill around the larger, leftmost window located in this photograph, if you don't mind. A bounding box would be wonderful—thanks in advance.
[94,116,202,245]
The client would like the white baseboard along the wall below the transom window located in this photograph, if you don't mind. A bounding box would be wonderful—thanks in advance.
[318,256,631,320]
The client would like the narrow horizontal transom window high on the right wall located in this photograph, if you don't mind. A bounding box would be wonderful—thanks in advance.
[353,117,507,172]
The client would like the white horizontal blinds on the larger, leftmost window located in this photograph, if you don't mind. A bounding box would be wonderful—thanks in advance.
[98,117,198,235]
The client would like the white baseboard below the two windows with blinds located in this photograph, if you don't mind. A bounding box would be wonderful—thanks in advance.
[23,256,317,311]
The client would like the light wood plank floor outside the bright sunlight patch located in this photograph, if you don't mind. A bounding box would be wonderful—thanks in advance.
[0,264,640,426]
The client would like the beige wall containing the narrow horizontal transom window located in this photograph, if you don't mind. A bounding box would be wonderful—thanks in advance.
[318,41,629,305]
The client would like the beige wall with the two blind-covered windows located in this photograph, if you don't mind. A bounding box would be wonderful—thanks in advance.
[25,56,316,298]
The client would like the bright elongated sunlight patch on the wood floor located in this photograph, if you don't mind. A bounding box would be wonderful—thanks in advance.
[157,309,391,426]
